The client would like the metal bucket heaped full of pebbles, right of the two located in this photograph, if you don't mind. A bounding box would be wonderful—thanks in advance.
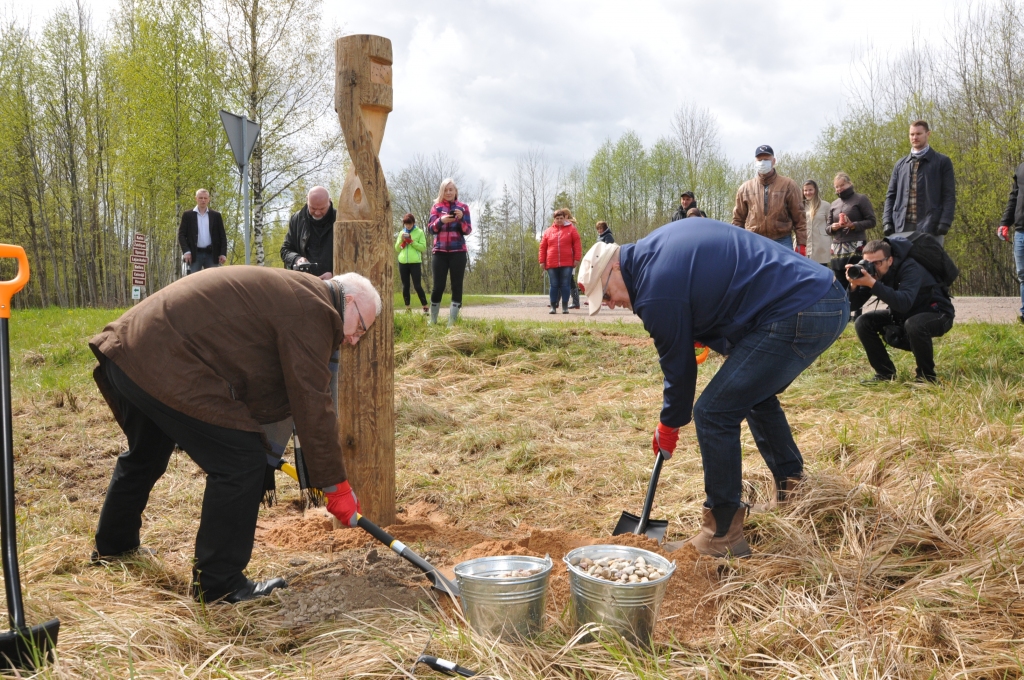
[563,546,676,646]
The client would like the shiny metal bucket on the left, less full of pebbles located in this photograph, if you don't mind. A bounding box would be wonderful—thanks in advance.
[455,555,551,641]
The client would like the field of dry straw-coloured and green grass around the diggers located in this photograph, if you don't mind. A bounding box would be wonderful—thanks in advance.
[2,309,1024,680]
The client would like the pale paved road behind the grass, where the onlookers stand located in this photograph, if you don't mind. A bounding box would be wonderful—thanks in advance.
[462,295,1021,324]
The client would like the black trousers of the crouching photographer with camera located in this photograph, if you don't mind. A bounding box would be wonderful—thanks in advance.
[854,309,953,378]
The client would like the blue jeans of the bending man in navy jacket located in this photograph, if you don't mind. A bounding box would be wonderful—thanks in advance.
[693,282,850,508]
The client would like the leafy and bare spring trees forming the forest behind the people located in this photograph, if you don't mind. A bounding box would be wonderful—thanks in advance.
[0,0,1024,307]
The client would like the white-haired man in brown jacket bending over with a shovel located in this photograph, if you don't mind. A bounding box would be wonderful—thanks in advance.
[89,267,381,602]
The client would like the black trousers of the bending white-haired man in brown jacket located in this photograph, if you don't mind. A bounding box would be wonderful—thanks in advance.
[96,360,267,601]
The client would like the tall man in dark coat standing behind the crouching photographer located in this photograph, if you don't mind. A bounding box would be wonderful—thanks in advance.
[882,121,956,243]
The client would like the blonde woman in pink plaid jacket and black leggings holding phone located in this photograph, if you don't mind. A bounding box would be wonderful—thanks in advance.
[427,177,473,326]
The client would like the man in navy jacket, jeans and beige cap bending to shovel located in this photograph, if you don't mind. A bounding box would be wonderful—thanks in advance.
[580,217,850,557]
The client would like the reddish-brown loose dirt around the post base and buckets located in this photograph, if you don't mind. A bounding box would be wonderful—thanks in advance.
[257,503,717,643]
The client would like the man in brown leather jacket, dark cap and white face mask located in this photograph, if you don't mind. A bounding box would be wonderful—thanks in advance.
[732,144,807,255]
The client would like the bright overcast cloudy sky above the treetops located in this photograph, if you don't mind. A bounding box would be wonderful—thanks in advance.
[9,0,983,187]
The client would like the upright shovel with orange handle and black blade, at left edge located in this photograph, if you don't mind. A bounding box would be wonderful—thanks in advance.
[0,244,60,671]
